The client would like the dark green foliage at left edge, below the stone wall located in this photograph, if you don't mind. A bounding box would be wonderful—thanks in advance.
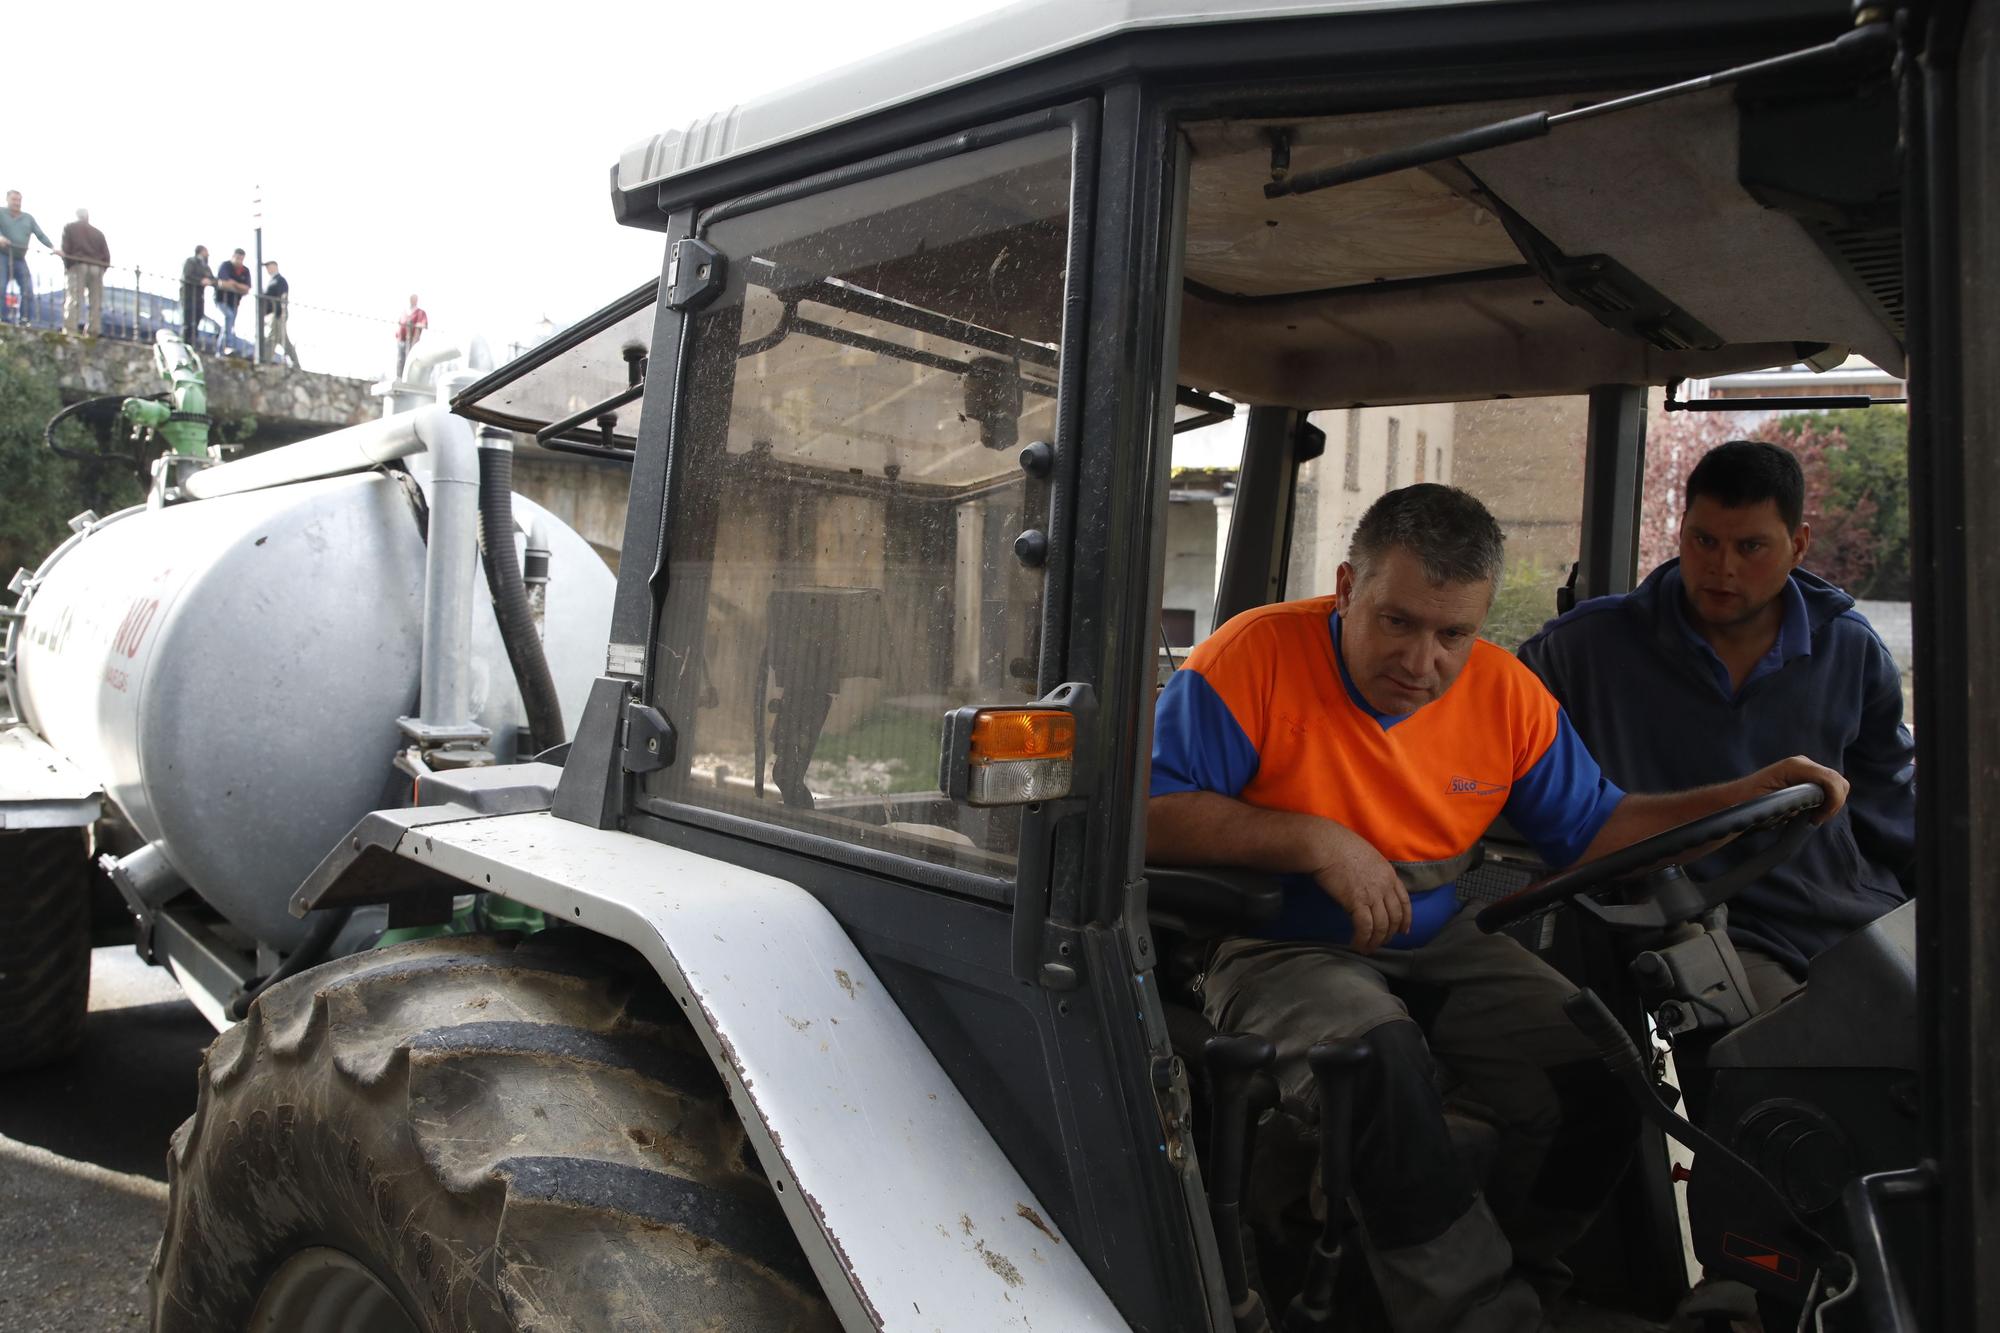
[0,340,140,582]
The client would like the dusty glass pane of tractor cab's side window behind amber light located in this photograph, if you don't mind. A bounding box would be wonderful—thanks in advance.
[648,128,1072,879]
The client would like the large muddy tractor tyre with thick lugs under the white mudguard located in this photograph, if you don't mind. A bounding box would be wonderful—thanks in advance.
[152,929,838,1333]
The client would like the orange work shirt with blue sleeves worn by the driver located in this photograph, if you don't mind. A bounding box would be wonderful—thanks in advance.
[1152,596,1624,949]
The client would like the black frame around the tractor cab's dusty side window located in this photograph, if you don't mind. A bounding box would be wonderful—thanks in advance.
[632,98,1102,907]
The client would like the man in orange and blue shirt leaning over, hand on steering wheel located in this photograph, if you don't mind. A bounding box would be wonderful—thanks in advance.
[1146,484,1846,1333]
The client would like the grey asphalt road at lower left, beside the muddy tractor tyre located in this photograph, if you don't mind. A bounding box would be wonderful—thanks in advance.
[0,947,214,1333]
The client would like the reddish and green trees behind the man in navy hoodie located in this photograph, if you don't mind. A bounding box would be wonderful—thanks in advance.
[1640,408,1910,600]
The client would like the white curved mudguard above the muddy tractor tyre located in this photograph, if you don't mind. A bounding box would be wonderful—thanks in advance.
[294,800,1126,1333]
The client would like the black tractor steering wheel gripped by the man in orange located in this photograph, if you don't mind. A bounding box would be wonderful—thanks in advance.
[1478,783,1826,935]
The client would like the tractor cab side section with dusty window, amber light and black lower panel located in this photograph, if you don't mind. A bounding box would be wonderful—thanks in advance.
[600,102,1208,1329]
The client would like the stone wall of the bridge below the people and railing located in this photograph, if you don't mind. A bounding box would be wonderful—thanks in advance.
[0,324,382,448]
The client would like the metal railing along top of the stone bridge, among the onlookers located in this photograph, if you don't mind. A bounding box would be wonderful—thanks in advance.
[0,252,396,378]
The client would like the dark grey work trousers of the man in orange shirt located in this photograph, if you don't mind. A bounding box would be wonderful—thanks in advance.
[1204,909,1638,1333]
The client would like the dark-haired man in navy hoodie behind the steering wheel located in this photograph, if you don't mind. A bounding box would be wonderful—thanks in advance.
[1520,440,1916,1009]
